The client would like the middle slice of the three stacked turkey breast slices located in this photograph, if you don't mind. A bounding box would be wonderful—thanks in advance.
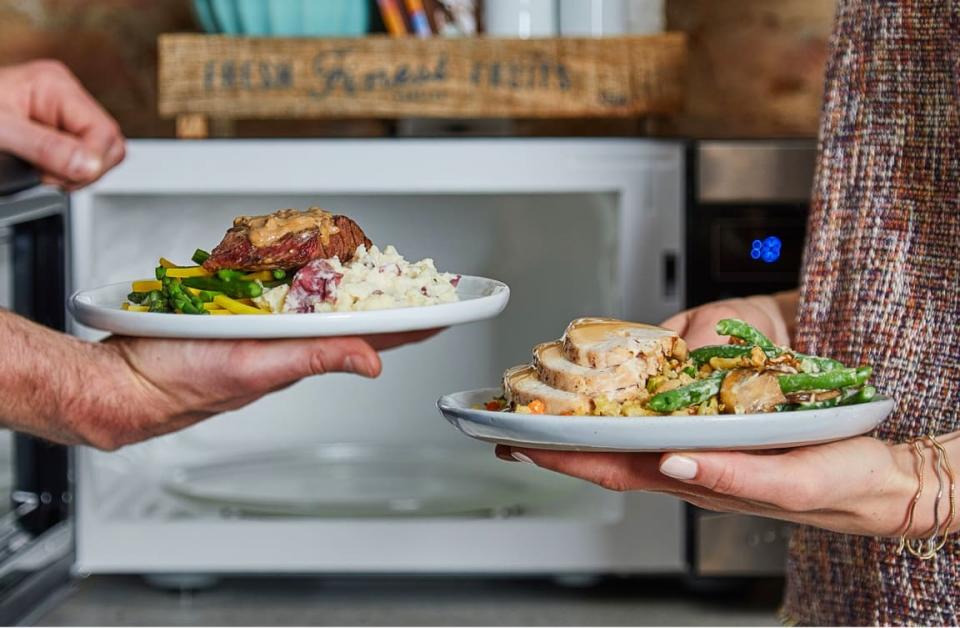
[533,341,659,401]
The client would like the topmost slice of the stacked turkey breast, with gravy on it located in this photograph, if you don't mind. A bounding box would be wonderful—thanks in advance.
[562,318,687,372]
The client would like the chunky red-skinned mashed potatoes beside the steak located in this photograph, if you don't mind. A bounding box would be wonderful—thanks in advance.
[257,245,460,312]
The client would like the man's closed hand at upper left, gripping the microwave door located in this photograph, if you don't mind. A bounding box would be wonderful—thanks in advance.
[0,60,126,189]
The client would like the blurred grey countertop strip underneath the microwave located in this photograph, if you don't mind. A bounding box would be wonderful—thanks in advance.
[30,576,780,626]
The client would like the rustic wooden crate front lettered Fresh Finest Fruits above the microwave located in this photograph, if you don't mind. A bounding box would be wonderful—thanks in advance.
[159,33,686,134]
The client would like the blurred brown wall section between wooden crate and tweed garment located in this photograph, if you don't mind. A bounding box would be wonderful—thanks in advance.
[657,0,836,138]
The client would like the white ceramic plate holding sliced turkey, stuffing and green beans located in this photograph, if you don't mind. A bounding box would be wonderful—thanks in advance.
[437,388,893,451]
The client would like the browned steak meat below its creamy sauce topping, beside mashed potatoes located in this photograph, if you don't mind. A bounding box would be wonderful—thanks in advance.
[203,210,371,272]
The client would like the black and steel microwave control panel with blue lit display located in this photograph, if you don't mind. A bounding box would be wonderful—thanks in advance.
[686,140,816,576]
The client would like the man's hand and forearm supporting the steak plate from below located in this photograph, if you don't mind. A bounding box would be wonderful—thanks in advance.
[0,312,437,450]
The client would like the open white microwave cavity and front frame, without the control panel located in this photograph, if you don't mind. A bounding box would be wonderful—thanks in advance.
[70,139,686,575]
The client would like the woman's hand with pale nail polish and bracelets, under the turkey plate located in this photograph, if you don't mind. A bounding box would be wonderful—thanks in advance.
[497,433,960,536]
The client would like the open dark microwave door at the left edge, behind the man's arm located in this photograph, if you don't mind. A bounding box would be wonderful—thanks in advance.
[0,184,73,625]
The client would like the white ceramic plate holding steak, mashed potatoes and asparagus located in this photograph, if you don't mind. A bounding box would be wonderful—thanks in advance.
[69,275,510,338]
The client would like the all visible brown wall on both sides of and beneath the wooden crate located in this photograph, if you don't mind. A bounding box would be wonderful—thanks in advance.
[0,0,835,137]
